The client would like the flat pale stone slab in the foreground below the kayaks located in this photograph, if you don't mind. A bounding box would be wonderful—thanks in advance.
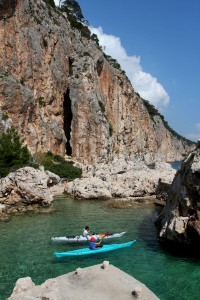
[8,261,159,300]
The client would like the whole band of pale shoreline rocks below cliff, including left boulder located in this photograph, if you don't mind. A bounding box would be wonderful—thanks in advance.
[0,159,176,220]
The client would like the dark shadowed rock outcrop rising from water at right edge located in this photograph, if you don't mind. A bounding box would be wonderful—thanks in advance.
[156,143,200,245]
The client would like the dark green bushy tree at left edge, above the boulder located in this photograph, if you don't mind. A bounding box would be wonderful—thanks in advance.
[0,127,31,177]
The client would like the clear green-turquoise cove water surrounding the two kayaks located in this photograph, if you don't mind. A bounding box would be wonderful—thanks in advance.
[0,197,200,300]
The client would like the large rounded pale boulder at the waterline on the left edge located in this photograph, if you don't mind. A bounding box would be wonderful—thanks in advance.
[0,167,60,218]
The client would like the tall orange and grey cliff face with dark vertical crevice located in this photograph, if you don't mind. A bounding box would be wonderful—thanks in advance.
[0,0,194,163]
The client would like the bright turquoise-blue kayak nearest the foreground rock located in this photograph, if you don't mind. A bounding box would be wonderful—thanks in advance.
[54,240,136,258]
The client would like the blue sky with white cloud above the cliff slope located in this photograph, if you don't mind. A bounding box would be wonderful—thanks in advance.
[55,0,200,141]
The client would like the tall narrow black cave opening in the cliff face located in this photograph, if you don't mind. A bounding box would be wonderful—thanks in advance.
[63,89,73,156]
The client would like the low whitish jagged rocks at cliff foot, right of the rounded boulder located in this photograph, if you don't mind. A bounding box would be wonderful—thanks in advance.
[65,158,176,199]
